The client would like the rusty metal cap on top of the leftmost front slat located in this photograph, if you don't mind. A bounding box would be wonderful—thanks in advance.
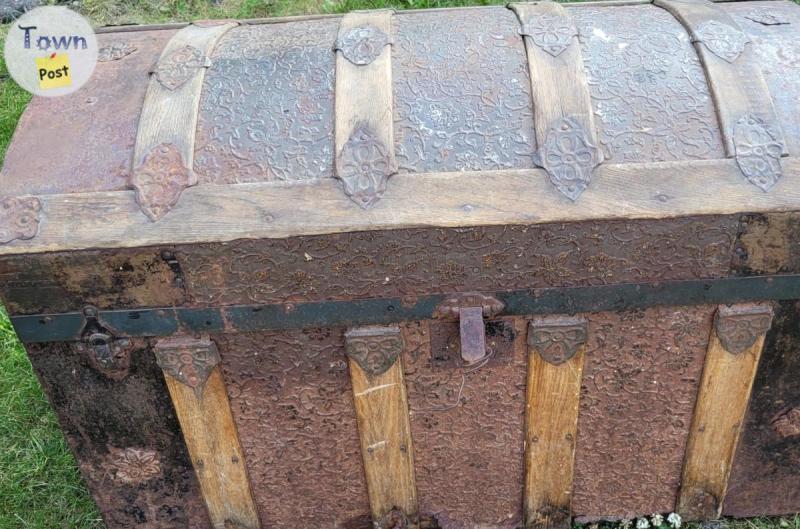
[154,336,220,392]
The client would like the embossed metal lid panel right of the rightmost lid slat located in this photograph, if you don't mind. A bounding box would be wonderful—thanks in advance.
[719,1,800,156]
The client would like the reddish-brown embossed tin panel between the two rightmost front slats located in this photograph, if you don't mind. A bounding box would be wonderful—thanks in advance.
[572,306,716,521]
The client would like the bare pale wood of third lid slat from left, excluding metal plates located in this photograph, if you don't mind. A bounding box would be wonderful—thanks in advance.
[509,2,597,151]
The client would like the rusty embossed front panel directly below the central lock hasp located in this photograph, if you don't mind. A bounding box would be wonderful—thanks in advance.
[403,318,527,529]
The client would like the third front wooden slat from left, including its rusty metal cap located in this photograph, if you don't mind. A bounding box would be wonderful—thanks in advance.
[524,317,586,529]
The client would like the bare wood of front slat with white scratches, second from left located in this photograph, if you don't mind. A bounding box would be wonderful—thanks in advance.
[349,330,418,529]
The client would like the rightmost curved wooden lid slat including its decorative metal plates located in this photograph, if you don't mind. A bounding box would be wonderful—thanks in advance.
[654,0,789,191]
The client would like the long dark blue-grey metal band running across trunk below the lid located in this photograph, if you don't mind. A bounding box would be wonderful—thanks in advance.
[11,274,800,343]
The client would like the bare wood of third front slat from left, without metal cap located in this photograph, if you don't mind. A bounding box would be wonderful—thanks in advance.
[524,318,585,529]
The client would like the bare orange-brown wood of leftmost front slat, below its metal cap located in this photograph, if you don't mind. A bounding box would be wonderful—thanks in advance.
[164,366,261,529]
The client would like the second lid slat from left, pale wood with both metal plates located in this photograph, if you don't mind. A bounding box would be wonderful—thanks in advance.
[334,10,397,208]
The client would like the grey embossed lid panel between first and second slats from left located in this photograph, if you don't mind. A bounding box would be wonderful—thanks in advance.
[194,20,338,184]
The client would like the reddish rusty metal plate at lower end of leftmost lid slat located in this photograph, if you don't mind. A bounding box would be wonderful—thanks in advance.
[131,143,195,222]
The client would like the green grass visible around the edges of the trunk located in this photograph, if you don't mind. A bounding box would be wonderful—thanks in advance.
[0,0,800,529]
